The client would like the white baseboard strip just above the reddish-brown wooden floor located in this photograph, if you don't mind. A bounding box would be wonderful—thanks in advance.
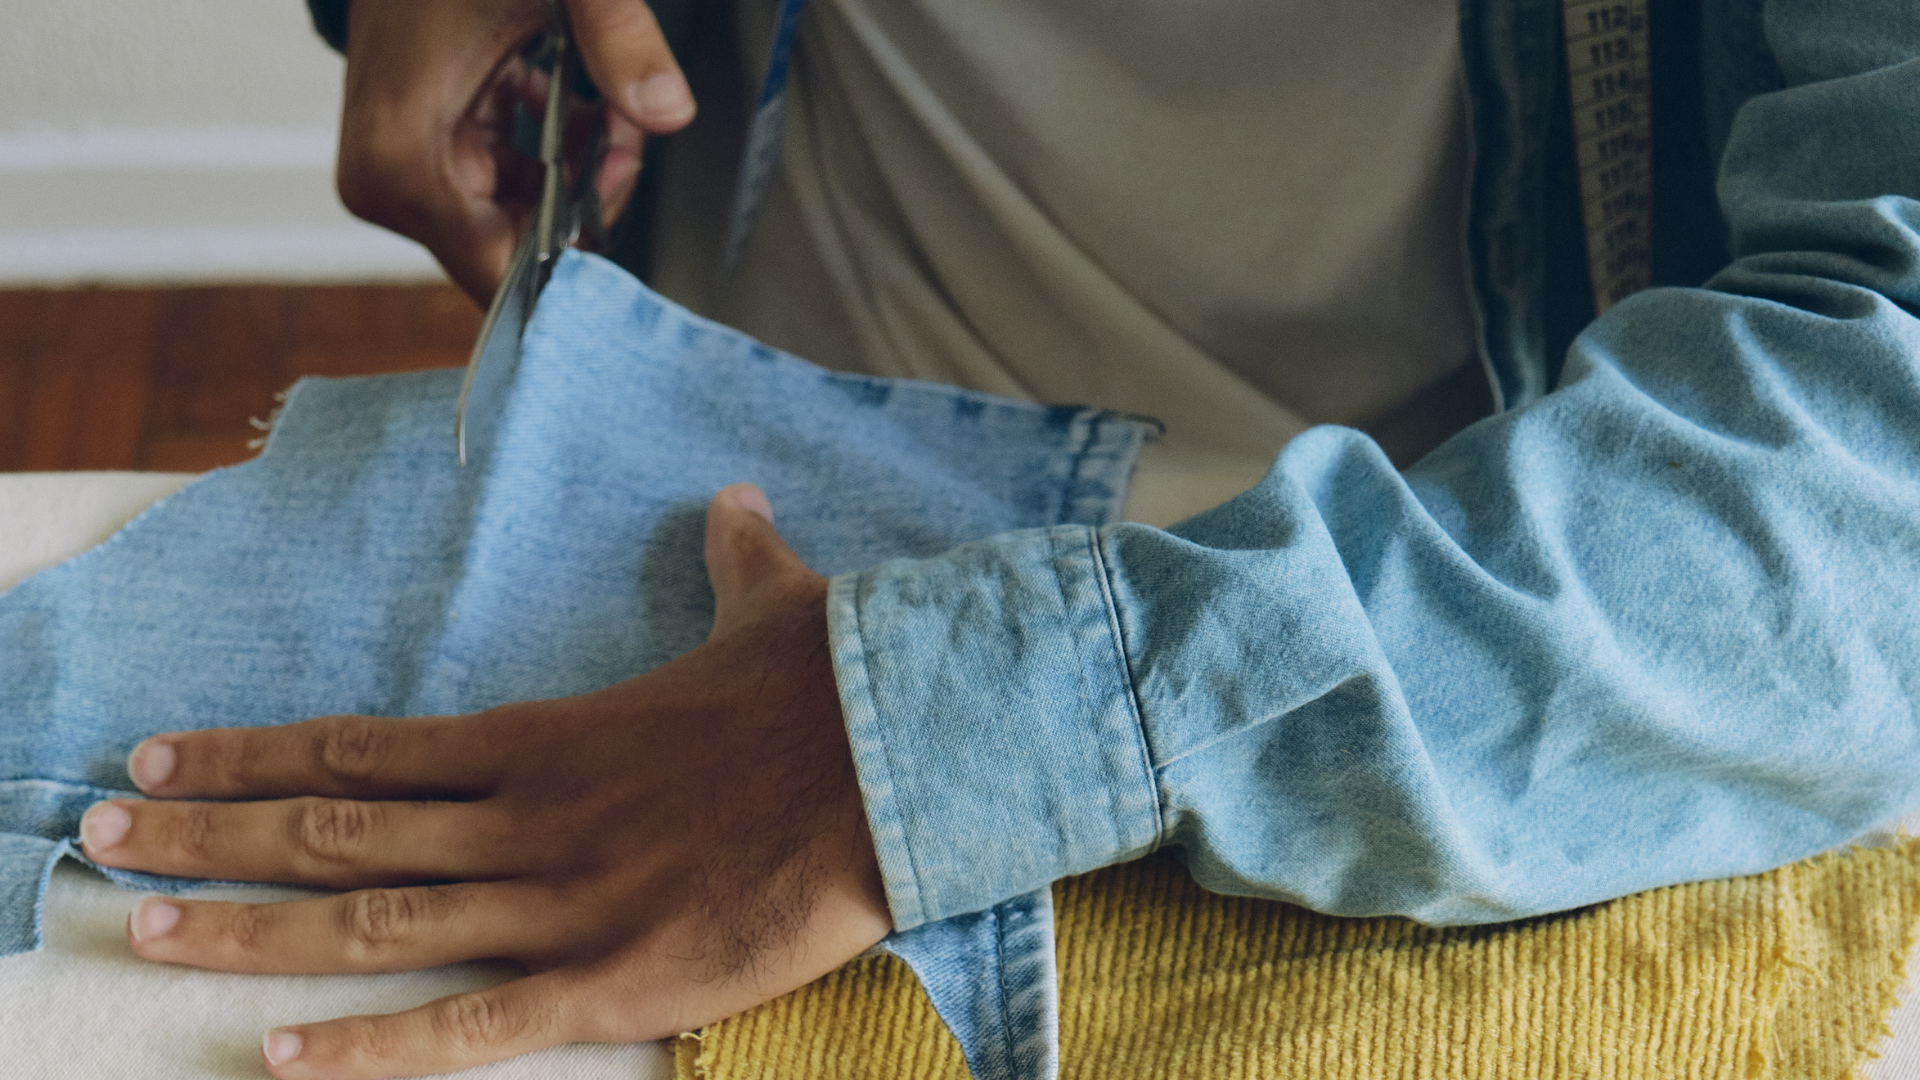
[0,129,444,286]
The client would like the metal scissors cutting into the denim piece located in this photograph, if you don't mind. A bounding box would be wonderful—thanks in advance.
[453,0,607,457]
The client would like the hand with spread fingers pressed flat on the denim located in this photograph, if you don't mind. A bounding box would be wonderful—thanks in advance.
[81,484,891,1080]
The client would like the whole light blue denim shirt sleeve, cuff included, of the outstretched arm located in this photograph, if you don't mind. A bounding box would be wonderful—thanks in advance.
[829,0,1920,928]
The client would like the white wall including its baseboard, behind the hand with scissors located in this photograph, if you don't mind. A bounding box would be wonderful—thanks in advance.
[0,0,440,284]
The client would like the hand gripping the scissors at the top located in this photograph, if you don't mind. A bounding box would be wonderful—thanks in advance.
[336,0,693,306]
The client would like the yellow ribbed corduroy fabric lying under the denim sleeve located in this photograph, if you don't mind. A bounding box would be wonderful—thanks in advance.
[674,842,1920,1080]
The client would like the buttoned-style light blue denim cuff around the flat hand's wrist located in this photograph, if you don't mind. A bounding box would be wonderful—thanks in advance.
[828,525,1160,930]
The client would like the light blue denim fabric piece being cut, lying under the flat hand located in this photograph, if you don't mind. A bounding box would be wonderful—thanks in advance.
[0,254,1142,1078]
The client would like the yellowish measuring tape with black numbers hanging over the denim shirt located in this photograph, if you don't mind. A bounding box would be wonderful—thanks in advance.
[1563,0,1653,315]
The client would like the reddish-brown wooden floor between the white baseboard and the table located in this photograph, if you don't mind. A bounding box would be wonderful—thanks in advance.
[0,284,480,473]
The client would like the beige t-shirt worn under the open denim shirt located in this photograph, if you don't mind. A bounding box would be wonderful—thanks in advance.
[655,0,1488,511]
